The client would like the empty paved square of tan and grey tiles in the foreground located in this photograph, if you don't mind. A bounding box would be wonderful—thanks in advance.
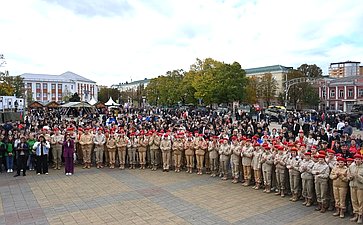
[0,167,352,225]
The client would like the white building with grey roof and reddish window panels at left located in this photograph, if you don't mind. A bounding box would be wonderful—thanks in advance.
[20,71,98,103]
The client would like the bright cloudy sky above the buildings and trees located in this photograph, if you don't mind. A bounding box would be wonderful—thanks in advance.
[0,0,363,86]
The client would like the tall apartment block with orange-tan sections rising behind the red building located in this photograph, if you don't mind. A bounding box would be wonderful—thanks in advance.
[329,61,363,78]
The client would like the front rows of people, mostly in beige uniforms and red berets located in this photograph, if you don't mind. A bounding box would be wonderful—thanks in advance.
[0,123,363,224]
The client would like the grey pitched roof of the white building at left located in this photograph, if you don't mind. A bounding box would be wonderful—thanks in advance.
[20,71,96,83]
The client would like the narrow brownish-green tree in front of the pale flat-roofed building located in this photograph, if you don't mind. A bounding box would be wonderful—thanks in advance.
[258,73,277,106]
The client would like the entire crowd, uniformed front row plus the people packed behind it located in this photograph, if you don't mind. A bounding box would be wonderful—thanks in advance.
[0,108,363,224]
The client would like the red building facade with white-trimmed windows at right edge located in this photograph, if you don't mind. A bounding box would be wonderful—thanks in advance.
[318,76,363,112]
